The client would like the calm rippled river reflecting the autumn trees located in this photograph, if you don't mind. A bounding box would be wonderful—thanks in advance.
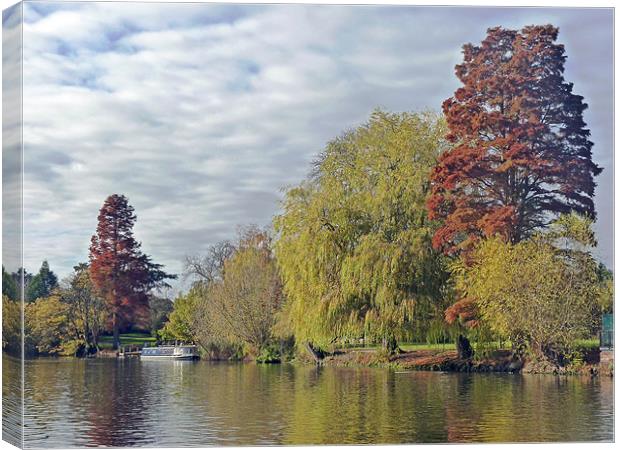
[3,357,613,447]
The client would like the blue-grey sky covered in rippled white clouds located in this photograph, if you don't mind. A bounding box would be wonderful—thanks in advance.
[8,3,613,284]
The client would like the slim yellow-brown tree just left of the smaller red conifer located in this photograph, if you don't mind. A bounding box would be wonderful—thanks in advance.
[60,263,108,354]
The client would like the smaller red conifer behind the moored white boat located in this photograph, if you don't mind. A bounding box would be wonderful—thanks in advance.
[89,194,176,349]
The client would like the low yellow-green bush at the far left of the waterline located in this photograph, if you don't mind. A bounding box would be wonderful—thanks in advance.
[25,294,70,355]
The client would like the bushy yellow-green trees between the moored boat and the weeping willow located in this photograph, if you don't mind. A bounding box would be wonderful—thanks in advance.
[159,227,282,359]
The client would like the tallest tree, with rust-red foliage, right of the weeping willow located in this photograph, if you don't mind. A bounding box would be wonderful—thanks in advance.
[428,25,601,254]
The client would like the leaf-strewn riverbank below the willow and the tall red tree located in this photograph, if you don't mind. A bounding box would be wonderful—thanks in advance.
[302,349,614,376]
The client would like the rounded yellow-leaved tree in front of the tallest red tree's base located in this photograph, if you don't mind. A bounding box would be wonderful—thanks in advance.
[454,215,601,360]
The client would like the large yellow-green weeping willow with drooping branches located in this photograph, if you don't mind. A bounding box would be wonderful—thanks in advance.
[274,111,447,351]
